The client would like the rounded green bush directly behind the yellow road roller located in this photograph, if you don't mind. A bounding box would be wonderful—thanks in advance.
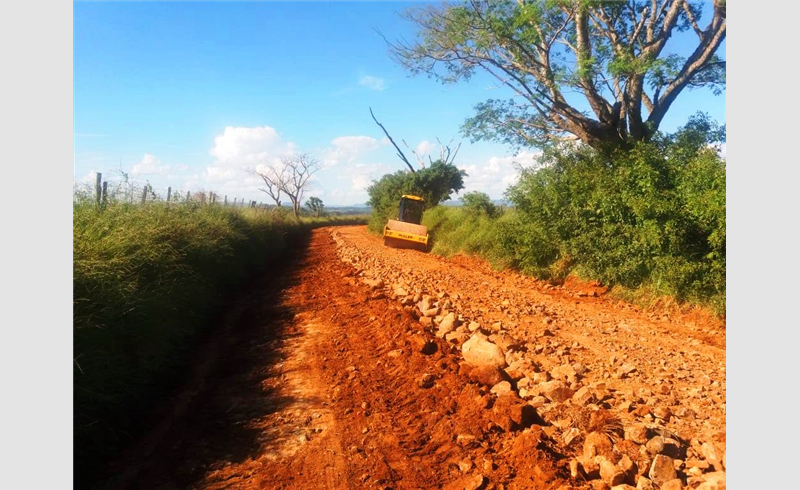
[367,160,467,233]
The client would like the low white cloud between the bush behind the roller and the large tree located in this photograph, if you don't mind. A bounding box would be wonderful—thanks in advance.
[459,151,540,199]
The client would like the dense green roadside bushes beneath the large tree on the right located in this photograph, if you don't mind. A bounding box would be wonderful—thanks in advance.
[423,116,726,315]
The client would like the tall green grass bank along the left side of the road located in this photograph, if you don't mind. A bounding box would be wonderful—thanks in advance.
[73,199,366,484]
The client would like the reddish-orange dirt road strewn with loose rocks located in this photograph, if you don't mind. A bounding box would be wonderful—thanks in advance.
[110,227,726,489]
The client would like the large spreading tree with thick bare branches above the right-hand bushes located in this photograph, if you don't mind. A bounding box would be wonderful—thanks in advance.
[389,0,726,148]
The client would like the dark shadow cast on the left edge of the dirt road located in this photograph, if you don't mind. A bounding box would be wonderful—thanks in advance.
[94,233,310,489]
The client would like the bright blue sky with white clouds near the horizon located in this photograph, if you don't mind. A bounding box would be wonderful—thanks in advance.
[73,2,725,205]
